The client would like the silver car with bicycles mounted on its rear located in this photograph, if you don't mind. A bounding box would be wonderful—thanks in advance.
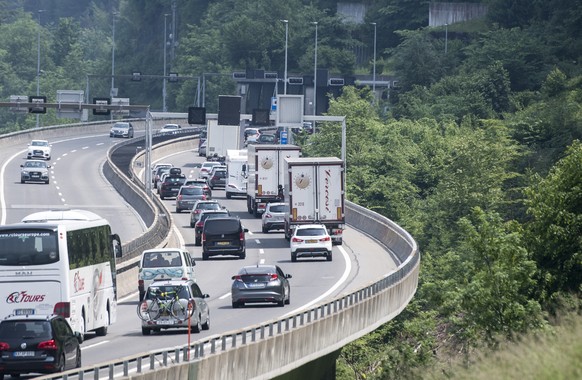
[138,280,210,335]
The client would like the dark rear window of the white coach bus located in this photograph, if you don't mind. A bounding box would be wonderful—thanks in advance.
[0,229,59,266]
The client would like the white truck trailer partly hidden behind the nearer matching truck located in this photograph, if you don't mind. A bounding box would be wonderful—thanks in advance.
[247,144,301,218]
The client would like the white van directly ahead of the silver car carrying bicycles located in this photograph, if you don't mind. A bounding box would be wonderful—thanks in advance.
[137,248,196,300]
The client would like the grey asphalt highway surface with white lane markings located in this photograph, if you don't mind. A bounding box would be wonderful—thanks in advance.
[0,131,396,366]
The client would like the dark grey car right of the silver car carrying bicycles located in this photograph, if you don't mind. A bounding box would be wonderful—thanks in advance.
[230,264,292,309]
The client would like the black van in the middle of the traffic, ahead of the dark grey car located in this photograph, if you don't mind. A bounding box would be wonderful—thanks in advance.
[202,216,249,260]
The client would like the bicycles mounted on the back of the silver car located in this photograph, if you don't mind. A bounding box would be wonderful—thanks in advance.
[137,285,194,322]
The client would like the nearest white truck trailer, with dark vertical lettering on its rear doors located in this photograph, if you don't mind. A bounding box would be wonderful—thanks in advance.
[283,157,345,245]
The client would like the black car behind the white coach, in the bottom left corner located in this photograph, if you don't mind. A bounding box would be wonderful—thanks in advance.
[0,315,83,377]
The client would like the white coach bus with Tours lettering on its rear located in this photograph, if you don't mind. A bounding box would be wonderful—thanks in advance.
[0,210,121,335]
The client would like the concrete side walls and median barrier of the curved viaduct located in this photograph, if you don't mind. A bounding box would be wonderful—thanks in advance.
[0,119,420,379]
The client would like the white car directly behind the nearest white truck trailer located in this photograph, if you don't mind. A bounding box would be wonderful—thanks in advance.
[291,224,332,262]
